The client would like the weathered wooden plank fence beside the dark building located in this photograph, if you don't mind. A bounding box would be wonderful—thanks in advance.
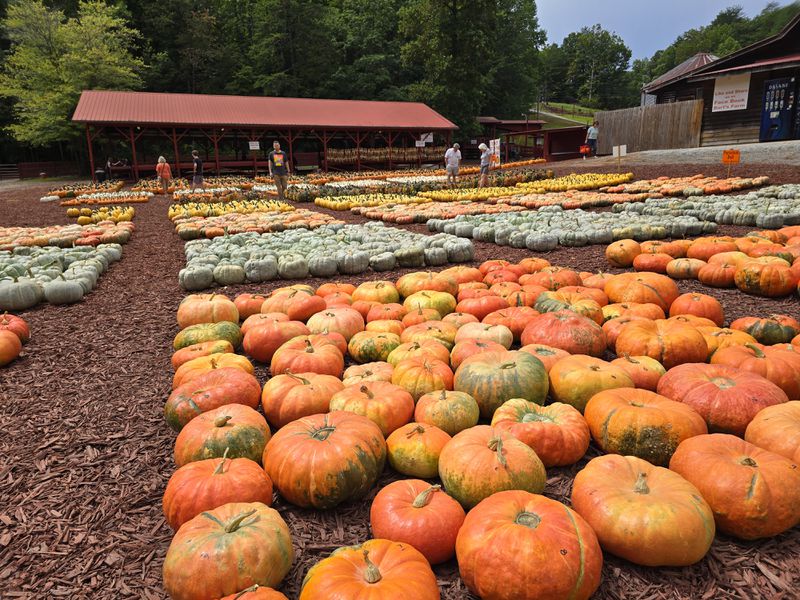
[595,100,703,154]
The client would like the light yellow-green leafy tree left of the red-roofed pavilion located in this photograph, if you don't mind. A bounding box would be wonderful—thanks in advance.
[0,0,145,146]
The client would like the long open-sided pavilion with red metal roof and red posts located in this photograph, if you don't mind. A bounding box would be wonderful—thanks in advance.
[72,91,457,179]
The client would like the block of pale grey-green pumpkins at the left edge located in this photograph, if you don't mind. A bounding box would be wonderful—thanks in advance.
[0,243,126,311]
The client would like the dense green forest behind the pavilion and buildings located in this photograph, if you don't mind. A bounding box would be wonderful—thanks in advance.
[0,0,800,163]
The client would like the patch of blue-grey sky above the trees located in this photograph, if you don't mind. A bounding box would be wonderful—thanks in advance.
[536,0,787,58]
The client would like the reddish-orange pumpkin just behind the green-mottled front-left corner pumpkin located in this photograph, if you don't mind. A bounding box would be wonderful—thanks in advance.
[162,455,272,531]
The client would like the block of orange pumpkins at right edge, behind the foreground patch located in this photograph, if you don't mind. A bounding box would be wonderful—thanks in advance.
[605,226,800,298]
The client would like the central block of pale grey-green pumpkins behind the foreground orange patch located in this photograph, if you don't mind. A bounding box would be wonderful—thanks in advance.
[179,223,474,290]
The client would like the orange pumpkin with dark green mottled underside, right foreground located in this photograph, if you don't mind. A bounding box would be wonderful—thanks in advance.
[584,389,708,467]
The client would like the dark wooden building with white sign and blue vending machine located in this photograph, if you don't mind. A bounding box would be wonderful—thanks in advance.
[642,15,800,146]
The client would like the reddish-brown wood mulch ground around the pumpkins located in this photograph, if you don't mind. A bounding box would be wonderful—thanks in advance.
[0,161,800,600]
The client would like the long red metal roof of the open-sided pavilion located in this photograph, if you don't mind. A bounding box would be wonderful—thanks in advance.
[72,90,457,131]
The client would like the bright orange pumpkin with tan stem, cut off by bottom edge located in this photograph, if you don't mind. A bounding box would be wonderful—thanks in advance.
[299,539,441,600]
